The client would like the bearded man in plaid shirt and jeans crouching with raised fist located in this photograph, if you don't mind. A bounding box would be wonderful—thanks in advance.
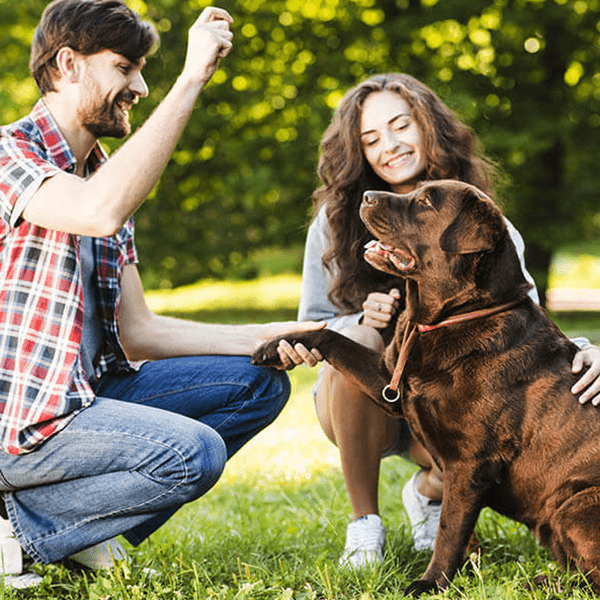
[0,0,320,587]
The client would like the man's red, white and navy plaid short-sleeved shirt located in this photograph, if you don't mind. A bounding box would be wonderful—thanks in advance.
[0,100,137,454]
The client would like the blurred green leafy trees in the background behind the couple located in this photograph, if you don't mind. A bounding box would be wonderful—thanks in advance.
[0,0,600,292]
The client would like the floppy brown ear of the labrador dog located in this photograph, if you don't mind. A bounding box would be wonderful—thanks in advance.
[440,189,504,254]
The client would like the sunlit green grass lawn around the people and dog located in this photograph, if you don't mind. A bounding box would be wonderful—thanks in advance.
[8,254,600,600]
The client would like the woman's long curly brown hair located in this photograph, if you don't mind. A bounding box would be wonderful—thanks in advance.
[313,73,497,313]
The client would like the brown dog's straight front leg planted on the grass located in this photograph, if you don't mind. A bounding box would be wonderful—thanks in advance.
[404,467,482,596]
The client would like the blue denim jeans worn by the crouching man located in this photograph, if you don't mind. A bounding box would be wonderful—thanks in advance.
[0,356,290,563]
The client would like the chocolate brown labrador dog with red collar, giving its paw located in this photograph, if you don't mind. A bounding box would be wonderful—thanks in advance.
[253,180,600,596]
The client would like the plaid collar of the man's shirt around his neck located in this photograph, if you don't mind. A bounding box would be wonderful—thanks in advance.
[31,98,107,173]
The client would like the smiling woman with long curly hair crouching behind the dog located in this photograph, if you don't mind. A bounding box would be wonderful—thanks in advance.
[280,74,600,568]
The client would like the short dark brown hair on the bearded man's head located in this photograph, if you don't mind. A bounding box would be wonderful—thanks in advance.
[29,0,158,94]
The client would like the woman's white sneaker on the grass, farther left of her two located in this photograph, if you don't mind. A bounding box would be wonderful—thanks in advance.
[340,515,385,569]
